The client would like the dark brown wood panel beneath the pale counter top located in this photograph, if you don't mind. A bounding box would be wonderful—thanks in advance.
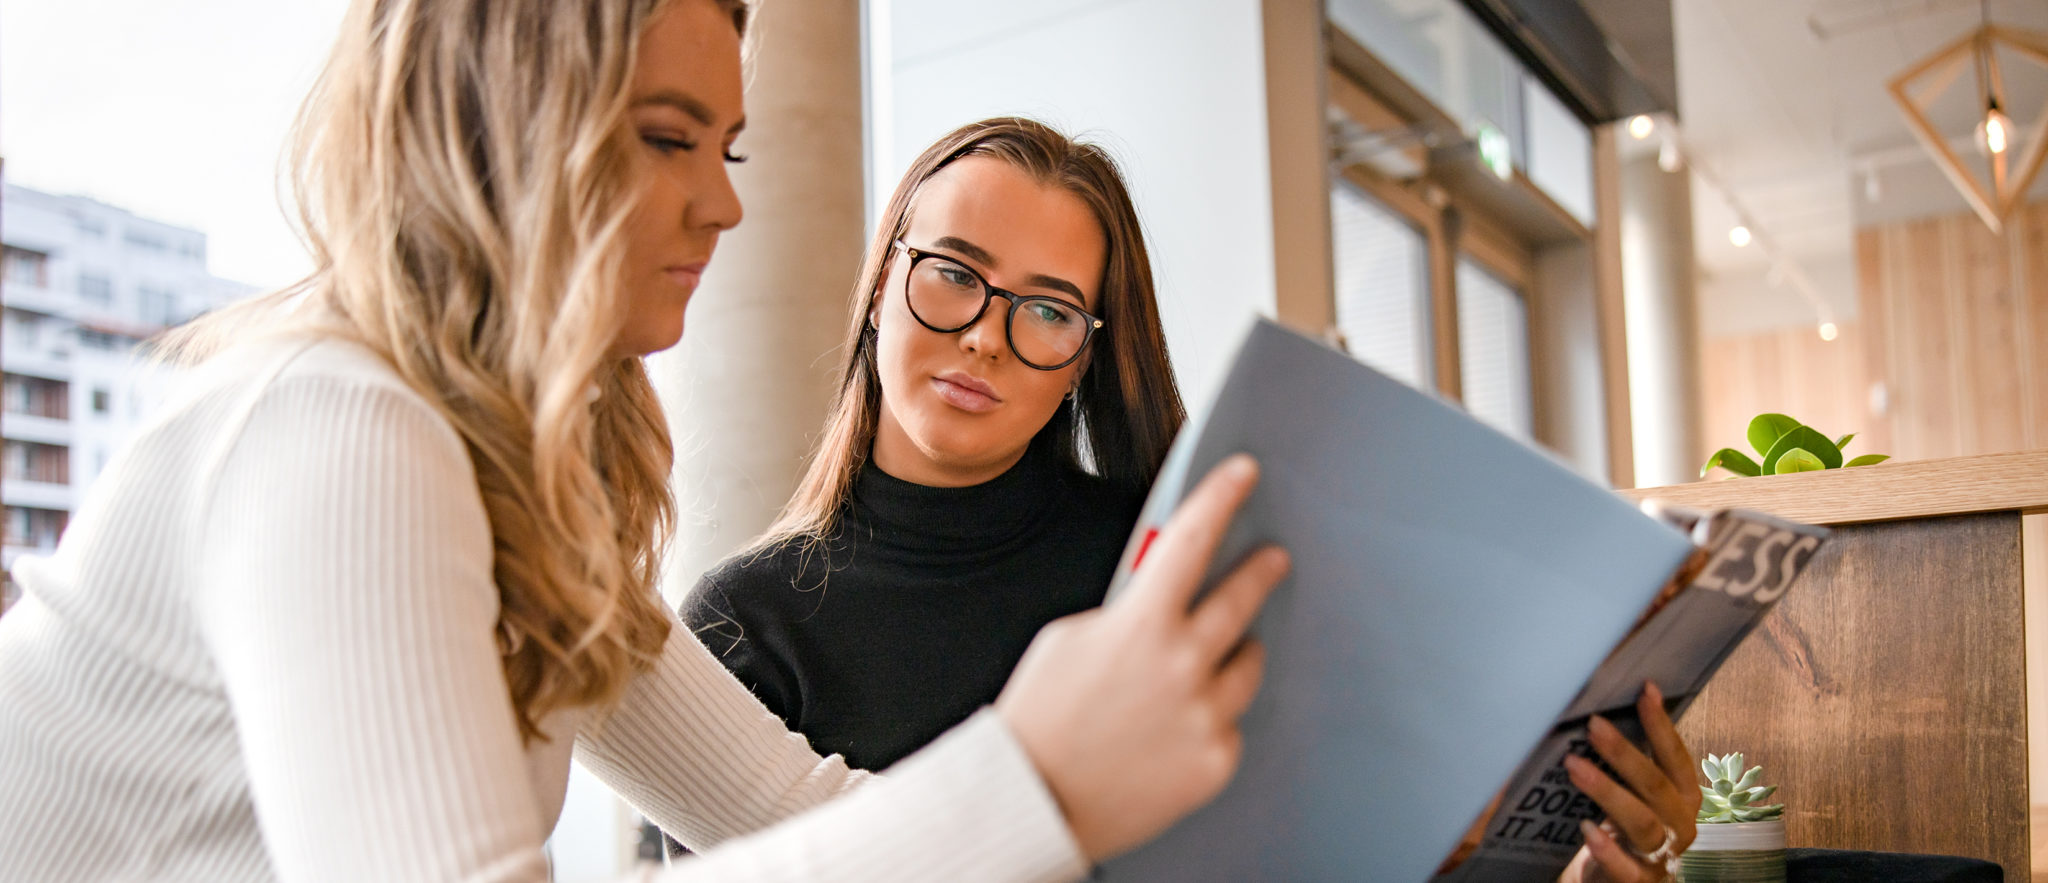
[1679,512,2030,881]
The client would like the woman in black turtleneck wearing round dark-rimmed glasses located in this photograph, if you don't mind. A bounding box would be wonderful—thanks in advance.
[684,119,1700,881]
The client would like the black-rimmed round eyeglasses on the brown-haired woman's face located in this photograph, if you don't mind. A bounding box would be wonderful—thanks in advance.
[895,240,1102,371]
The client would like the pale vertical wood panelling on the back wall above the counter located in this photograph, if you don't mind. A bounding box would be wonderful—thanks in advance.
[1702,203,2048,471]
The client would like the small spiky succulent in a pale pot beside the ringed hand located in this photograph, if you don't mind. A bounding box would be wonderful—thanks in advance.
[1677,752,1786,883]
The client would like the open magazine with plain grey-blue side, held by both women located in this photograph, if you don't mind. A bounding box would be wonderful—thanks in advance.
[1102,322,1827,883]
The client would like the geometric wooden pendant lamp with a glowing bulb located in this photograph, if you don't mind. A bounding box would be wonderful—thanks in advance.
[1888,20,2048,232]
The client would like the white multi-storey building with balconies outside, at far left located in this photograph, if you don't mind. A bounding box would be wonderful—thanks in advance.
[0,184,252,600]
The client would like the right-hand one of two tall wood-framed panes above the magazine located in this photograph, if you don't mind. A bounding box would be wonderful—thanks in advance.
[1458,260,1534,443]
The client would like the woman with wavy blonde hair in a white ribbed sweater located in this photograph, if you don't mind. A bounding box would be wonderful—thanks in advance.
[0,0,1286,881]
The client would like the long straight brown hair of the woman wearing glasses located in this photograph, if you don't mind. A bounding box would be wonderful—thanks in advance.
[754,117,1188,549]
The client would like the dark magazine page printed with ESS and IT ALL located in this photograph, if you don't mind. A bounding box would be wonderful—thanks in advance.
[1436,510,1827,883]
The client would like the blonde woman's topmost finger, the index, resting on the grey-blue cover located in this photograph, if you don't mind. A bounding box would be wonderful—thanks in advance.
[1112,455,1260,621]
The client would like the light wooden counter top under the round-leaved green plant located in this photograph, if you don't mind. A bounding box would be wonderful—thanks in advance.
[1618,451,2048,524]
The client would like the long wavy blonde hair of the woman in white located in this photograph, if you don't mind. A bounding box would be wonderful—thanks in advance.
[164,0,748,740]
